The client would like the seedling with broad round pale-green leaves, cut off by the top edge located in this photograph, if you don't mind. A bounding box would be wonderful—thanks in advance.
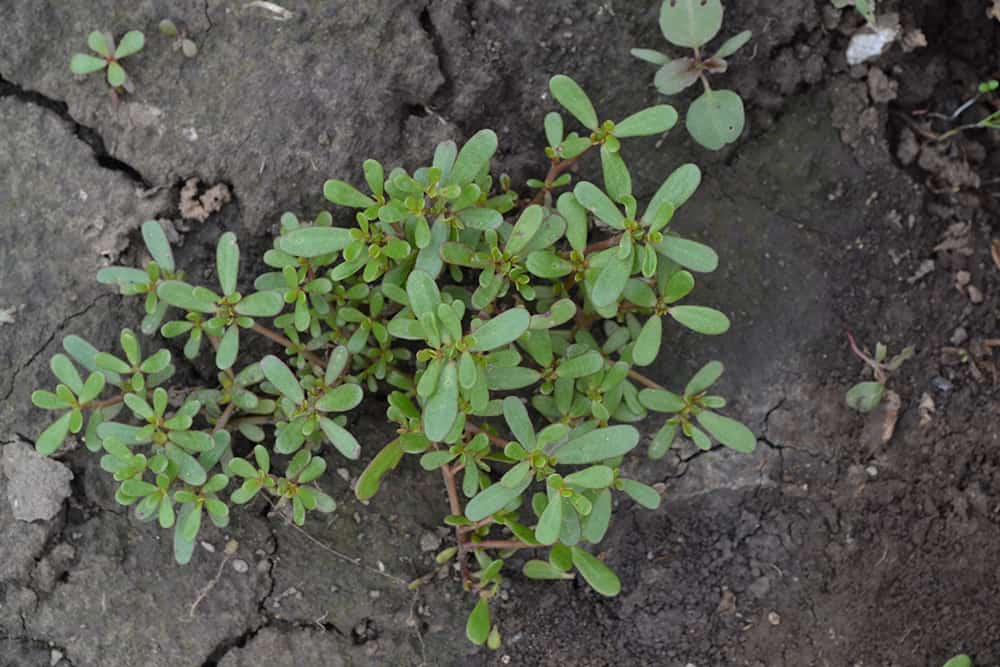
[632,0,753,151]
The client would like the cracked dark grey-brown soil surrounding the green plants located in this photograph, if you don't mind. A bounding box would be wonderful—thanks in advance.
[0,0,1000,667]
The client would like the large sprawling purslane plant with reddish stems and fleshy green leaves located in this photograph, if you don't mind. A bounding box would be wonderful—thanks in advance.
[32,76,756,647]
